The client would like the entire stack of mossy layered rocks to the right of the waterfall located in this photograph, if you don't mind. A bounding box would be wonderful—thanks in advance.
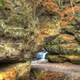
[44,22,80,64]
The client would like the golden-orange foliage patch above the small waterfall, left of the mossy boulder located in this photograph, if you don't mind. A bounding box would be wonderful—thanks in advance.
[35,24,56,45]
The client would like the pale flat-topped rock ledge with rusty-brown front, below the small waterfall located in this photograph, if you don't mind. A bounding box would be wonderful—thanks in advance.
[31,61,80,80]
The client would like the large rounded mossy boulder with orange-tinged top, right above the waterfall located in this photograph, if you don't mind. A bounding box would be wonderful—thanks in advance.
[45,33,80,54]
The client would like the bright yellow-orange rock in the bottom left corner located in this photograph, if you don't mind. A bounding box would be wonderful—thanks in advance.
[0,62,31,80]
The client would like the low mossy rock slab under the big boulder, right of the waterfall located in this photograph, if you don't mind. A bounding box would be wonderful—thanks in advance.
[47,54,80,64]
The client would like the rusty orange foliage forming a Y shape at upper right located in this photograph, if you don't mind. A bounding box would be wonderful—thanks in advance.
[42,0,80,26]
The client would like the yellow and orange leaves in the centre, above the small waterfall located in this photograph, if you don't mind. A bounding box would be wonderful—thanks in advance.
[35,23,58,45]
